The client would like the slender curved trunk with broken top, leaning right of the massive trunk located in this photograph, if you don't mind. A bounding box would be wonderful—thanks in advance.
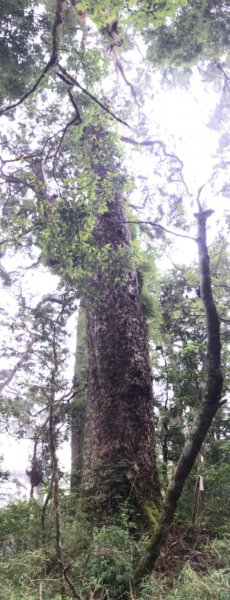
[136,210,223,582]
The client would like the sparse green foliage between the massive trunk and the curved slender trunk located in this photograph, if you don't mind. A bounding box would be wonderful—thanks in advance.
[154,267,205,464]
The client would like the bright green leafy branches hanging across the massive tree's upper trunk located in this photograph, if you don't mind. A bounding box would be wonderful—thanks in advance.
[1,109,132,297]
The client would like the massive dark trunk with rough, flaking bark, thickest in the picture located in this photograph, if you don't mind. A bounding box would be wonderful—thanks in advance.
[84,193,160,519]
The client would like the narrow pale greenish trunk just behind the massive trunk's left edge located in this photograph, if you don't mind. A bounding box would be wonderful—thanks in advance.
[70,306,87,494]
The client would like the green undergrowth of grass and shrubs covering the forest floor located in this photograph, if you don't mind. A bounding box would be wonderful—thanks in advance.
[0,496,230,600]
